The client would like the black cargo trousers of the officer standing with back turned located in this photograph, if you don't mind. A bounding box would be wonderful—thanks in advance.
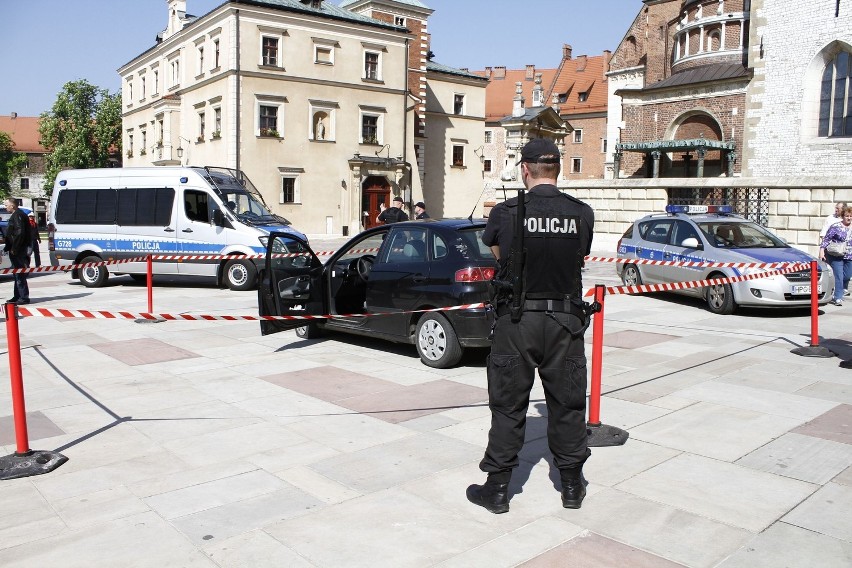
[479,311,590,473]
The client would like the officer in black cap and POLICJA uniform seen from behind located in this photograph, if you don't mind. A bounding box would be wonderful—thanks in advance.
[467,138,595,513]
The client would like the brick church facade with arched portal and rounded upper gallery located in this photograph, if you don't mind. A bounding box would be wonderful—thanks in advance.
[608,0,751,177]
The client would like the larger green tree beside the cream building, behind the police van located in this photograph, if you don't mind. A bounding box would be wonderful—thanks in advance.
[39,79,121,194]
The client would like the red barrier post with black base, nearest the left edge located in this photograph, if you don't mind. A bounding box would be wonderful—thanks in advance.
[0,303,68,479]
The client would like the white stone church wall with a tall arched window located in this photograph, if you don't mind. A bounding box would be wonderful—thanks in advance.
[743,0,852,176]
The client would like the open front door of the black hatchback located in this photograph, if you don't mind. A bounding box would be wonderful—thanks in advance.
[257,233,328,335]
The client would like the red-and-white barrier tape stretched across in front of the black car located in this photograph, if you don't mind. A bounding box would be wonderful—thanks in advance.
[17,302,486,321]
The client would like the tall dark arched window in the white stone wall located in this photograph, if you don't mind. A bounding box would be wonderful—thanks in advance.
[819,51,852,136]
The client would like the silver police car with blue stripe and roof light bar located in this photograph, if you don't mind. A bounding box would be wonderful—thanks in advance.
[616,205,834,314]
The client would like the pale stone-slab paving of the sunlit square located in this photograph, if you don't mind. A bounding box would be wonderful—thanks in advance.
[0,238,852,568]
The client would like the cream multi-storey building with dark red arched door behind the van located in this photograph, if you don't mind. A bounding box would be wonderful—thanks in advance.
[119,0,485,235]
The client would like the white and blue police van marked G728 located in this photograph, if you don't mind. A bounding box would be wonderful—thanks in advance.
[48,166,307,290]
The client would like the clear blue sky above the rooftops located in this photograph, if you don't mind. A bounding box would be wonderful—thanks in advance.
[0,0,642,116]
